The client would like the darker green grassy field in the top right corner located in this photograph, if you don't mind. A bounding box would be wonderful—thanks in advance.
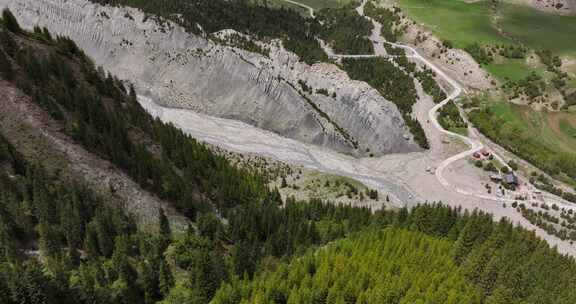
[500,4,576,55]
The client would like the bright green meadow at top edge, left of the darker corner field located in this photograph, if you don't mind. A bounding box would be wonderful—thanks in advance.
[398,0,510,48]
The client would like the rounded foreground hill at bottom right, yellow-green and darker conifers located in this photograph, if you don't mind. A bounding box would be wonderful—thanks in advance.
[213,205,576,304]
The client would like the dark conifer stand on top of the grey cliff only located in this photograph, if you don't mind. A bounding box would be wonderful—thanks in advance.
[90,0,328,64]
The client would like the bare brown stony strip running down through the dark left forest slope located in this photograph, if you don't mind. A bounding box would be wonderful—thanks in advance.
[0,80,186,228]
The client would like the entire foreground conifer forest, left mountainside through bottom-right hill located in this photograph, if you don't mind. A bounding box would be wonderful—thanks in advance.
[0,11,576,304]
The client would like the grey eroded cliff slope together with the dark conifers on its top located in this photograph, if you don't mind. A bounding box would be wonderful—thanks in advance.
[0,0,418,156]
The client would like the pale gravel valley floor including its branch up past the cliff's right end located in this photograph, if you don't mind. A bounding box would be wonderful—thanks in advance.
[140,0,576,255]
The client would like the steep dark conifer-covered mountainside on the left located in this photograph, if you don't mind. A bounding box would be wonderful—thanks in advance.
[0,11,342,303]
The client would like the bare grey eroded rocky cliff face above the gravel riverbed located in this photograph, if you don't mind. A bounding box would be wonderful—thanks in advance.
[0,0,418,156]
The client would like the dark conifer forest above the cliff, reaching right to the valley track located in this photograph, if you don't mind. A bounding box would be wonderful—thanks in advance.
[90,0,374,64]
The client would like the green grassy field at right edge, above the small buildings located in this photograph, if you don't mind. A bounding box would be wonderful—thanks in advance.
[468,98,576,187]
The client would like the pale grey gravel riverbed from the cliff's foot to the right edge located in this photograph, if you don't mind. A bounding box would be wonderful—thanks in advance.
[139,92,576,255]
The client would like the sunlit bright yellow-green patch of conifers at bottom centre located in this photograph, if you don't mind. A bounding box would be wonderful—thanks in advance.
[214,229,481,304]
